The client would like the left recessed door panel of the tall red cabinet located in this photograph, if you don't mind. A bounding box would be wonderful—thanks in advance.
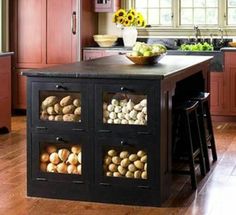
[15,0,46,68]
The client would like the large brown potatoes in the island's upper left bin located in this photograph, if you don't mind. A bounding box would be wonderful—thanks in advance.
[40,95,81,122]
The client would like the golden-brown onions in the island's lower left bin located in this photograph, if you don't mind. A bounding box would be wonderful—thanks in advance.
[40,145,82,175]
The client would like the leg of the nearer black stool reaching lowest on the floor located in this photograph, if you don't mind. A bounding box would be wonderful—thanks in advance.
[184,114,197,190]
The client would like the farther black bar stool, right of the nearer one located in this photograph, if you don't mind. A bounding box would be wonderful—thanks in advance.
[191,92,217,171]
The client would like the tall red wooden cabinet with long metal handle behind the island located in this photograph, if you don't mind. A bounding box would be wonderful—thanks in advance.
[9,0,97,109]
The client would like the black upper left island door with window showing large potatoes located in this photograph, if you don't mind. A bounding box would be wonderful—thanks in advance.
[30,81,89,131]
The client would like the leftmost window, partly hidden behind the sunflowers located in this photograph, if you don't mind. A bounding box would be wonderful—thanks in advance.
[134,0,172,26]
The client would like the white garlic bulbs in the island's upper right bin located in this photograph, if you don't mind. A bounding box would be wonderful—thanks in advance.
[103,99,147,125]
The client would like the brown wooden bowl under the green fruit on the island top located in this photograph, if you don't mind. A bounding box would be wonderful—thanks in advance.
[126,54,165,65]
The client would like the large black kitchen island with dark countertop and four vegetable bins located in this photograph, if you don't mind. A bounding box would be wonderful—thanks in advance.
[23,56,212,206]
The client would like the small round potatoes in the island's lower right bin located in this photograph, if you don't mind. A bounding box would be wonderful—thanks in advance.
[103,149,147,179]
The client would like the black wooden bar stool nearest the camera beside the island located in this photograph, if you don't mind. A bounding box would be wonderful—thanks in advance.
[172,101,206,189]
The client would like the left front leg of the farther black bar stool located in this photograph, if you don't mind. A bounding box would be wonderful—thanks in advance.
[198,104,210,172]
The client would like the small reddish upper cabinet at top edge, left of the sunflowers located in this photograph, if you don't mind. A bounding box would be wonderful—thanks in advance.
[95,0,120,12]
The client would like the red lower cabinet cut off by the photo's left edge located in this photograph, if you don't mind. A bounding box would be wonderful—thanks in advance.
[0,55,11,132]
